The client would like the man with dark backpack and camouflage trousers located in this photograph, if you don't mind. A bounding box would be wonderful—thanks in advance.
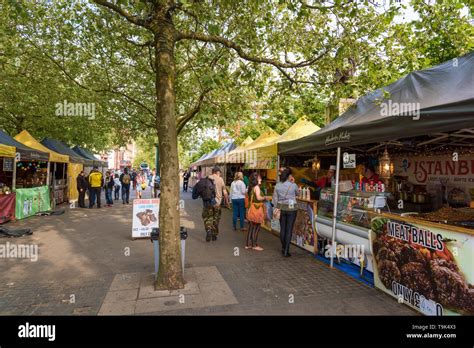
[192,167,227,242]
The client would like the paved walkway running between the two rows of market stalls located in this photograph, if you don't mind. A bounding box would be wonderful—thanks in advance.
[0,188,415,315]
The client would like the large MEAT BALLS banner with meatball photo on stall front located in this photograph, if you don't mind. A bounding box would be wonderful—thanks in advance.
[371,217,474,315]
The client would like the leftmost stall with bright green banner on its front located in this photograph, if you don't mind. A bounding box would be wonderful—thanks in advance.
[0,131,51,222]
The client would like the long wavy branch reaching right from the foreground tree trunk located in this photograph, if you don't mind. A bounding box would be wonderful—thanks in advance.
[176,32,328,69]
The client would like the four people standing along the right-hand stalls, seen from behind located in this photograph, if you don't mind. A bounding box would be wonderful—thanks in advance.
[192,167,298,257]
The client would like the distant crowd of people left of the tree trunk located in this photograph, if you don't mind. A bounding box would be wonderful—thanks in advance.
[76,166,160,209]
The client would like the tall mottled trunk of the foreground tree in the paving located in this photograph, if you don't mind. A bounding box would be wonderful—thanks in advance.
[155,18,184,290]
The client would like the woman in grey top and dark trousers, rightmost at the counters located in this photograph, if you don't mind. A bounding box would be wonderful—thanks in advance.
[272,169,298,257]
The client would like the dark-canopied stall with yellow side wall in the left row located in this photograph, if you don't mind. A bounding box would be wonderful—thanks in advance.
[41,138,92,203]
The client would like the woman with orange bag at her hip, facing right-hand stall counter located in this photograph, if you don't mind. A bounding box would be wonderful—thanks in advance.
[245,173,271,251]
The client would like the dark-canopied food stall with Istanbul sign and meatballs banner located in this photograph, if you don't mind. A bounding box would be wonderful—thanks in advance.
[279,52,474,315]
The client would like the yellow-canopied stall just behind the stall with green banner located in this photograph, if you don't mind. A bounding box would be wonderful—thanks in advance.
[15,130,69,204]
